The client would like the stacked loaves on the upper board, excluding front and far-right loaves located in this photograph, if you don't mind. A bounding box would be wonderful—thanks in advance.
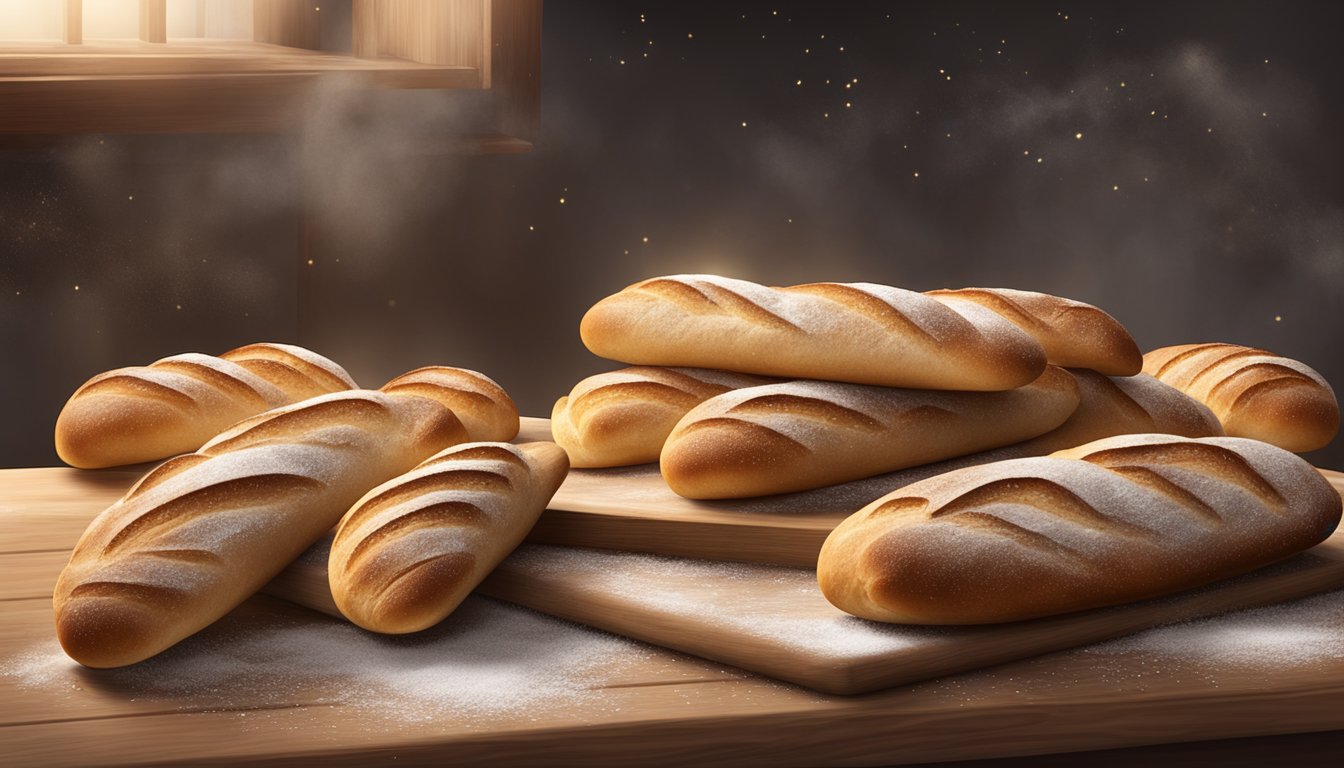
[551,276,1222,499]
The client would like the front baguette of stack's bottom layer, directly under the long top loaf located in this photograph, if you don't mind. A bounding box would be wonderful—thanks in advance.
[660,366,1078,499]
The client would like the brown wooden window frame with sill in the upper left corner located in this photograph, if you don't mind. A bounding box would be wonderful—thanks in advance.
[0,0,542,152]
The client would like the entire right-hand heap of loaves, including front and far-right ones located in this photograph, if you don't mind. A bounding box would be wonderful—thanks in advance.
[552,276,1341,624]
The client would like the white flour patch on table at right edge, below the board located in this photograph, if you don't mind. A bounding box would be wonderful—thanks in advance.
[1086,590,1344,668]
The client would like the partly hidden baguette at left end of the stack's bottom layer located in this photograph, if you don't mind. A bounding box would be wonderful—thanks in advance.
[551,366,775,468]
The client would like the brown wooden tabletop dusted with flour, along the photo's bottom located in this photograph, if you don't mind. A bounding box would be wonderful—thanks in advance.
[0,468,1344,765]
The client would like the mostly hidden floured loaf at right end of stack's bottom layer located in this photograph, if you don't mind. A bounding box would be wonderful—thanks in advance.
[1013,369,1223,457]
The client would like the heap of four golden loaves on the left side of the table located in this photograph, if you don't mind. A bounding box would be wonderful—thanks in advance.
[54,344,569,667]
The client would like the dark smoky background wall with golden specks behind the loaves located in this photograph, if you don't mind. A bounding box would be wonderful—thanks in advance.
[0,0,1344,468]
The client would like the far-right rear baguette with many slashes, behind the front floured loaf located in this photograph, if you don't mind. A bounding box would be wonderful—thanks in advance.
[1144,344,1340,452]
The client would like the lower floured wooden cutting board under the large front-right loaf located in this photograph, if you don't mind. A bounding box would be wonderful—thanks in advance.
[266,508,1344,695]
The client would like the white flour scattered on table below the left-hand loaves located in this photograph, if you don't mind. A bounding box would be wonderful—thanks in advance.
[0,597,648,722]
